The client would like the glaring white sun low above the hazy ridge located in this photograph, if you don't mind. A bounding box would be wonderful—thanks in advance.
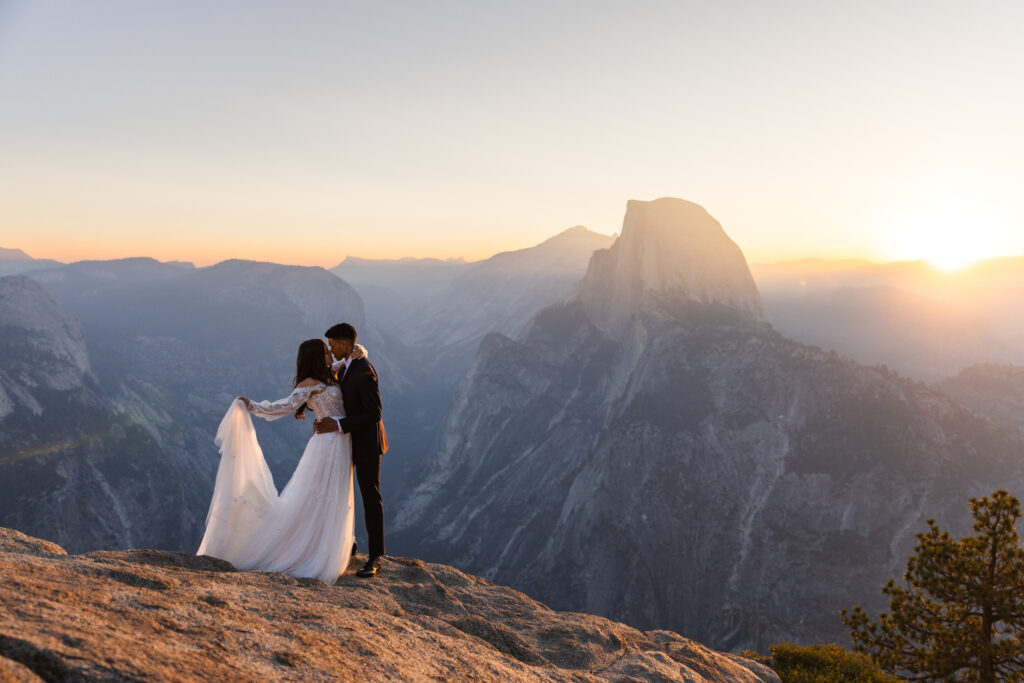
[886,197,1011,271]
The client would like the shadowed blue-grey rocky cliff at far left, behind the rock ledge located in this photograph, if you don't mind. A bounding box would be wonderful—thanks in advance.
[0,275,199,548]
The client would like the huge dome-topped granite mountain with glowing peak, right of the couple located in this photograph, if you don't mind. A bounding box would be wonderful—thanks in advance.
[391,198,1024,649]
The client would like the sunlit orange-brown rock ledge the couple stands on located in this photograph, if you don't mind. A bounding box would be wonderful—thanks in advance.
[0,528,778,683]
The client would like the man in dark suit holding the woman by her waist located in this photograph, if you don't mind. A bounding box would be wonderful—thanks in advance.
[313,323,387,579]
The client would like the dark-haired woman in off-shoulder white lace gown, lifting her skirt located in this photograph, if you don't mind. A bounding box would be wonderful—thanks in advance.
[197,339,366,584]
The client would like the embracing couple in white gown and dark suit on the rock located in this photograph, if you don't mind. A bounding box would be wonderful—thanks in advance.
[198,323,387,584]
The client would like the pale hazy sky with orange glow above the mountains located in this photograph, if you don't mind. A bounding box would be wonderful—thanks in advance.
[0,0,1024,267]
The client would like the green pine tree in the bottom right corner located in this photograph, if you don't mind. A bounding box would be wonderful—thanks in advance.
[841,490,1024,683]
